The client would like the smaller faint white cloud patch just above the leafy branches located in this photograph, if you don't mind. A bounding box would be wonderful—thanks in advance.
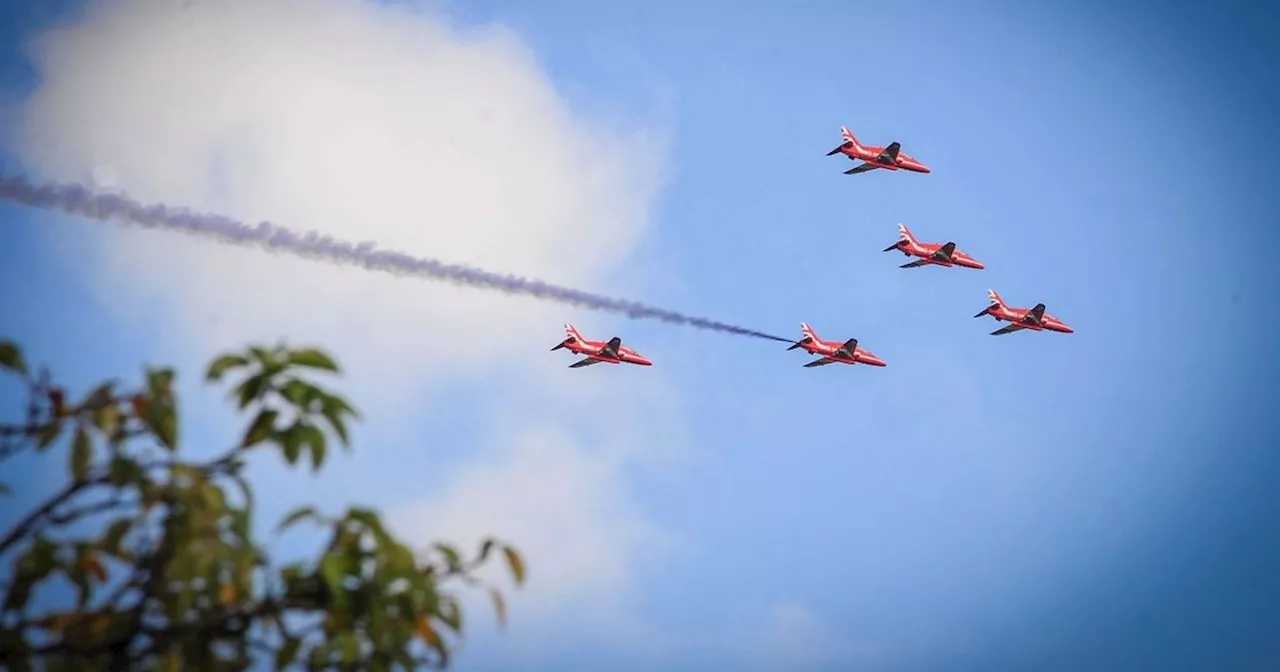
[393,428,667,623]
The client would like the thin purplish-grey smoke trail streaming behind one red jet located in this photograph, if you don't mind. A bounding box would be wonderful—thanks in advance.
[0,175,794,343]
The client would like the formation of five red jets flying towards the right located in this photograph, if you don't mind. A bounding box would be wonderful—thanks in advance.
[552,127,1075,369]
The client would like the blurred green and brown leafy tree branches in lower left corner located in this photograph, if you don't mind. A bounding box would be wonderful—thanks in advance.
[0,340,525,671]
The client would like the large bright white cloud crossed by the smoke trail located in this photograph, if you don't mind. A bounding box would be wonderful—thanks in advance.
[20,0,658,378]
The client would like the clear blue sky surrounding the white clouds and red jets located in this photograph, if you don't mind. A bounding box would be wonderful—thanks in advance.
[0,1,1280,669]
